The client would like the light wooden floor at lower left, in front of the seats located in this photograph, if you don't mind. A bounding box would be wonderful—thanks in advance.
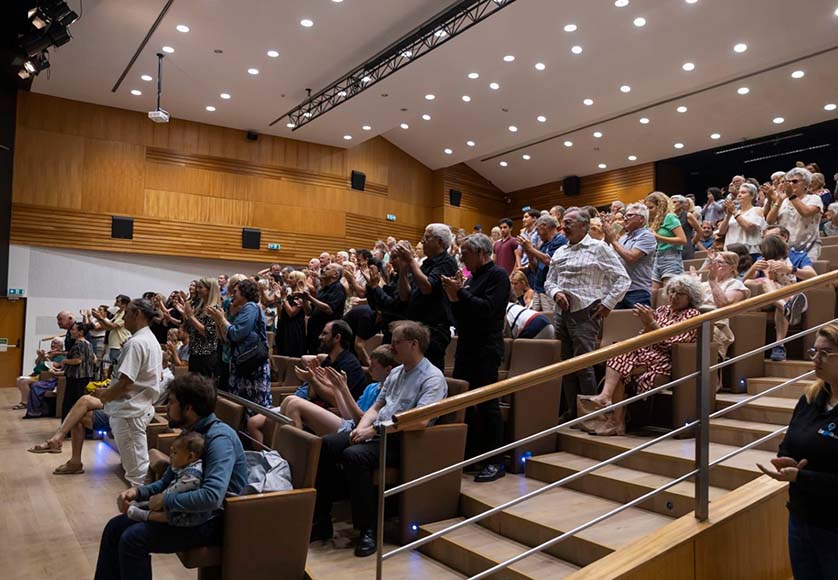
[0,388,192,580]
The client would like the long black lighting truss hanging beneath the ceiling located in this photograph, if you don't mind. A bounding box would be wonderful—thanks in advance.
[271,0,515,131]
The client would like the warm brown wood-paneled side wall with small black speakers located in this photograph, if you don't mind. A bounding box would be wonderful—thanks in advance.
[11,93,434,264]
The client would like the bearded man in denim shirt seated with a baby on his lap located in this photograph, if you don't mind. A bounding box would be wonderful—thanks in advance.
[95,374,247,580]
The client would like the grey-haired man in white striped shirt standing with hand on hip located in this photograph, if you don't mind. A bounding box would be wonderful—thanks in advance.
[544,208,631,420]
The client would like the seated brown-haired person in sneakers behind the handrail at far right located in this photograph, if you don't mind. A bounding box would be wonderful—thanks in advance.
[745,236,807,361]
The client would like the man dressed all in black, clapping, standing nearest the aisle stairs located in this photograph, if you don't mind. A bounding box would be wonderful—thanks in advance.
[442,233,516,483]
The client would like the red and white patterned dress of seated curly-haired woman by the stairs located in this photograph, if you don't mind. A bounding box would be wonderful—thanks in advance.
[607,304,700,394]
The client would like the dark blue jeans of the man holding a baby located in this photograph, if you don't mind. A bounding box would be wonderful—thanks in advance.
[94,515,223,580]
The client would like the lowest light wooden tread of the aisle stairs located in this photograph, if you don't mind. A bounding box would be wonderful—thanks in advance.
[420,518,579,579]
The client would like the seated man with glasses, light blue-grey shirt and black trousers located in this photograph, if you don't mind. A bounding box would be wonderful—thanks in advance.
[311,321,448,557]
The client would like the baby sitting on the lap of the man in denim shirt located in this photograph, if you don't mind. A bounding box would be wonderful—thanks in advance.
[125,431,214,527]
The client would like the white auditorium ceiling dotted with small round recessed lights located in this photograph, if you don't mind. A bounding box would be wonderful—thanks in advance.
[33,0,838,191]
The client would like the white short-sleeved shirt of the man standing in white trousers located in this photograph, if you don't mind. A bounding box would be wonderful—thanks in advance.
[105,326,163,417]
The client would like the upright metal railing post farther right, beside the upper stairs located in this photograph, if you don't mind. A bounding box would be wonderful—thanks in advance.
[695,322,713,522]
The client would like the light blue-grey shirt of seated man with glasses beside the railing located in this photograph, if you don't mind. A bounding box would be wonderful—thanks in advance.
[375,358,448,426]
